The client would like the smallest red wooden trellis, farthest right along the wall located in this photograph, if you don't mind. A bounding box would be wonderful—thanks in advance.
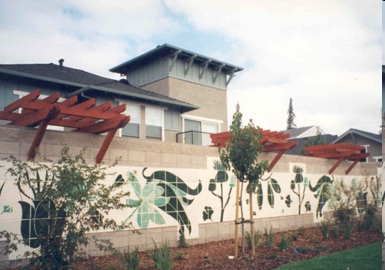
[304,143,370,174]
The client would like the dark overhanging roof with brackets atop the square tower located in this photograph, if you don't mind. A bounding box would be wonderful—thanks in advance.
[110,44,243,74]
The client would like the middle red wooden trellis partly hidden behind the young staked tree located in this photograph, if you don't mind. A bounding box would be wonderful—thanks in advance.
[210,129,297,172]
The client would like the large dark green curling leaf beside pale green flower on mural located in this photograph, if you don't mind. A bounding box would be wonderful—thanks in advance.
[142,168,202,233]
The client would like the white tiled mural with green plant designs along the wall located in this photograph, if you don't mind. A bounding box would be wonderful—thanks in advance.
[0,158,381,260]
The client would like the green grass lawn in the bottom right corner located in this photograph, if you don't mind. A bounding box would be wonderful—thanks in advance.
[277,242,382,270]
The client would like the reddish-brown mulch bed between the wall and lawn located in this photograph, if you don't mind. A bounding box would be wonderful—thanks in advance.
[74,227,382,270]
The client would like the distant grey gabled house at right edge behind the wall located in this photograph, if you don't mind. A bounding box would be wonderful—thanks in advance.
[332,128,382,162]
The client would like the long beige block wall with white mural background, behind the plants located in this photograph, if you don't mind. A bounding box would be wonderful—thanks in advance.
[0,126,381,260]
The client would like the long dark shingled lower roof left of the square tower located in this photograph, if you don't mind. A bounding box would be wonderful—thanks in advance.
[0,63,199,112]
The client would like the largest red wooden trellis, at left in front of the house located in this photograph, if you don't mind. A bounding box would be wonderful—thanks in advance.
[0,89,130,163]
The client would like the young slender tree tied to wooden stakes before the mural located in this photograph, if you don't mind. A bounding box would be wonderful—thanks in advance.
[219,112,268,257]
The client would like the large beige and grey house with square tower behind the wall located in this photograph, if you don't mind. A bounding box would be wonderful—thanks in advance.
[0,44,242,145]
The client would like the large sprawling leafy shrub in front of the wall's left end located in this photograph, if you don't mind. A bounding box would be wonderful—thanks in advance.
[0,148,131,269]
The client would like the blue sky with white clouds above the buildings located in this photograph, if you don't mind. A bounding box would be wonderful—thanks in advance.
[0,0,385,135]
